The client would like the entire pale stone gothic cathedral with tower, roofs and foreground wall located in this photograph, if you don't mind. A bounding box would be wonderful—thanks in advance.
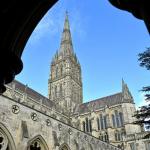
[0,14,150,150]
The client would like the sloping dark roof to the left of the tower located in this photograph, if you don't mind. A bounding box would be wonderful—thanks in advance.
[8,80,55,107]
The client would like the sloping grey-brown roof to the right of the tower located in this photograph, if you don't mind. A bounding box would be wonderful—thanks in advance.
[77,92,125,114]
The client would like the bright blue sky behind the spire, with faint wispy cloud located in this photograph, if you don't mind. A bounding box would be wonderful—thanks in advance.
[16,0,150,107]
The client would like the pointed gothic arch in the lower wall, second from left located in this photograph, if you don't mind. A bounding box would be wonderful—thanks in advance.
[27,135,49,150]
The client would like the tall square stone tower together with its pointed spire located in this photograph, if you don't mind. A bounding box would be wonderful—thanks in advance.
[48,13,82,112]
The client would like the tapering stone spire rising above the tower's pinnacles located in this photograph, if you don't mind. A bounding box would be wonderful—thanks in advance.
[60,11,73,55]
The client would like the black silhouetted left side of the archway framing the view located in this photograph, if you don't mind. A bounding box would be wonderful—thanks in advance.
[0,0,58,93]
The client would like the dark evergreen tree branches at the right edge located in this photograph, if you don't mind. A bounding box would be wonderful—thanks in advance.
[135,47,150,138]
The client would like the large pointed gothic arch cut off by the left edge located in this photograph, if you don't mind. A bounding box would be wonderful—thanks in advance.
[0,123,16,150]
